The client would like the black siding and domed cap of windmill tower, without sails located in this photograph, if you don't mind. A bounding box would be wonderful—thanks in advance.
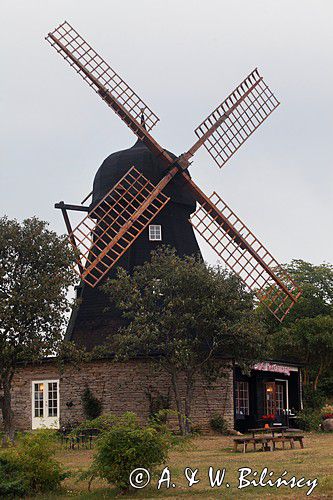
[67,140,200,349]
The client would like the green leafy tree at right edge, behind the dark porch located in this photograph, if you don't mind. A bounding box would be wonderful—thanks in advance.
[266,260,333,391]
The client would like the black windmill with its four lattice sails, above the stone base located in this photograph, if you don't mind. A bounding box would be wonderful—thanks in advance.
[46,22,301,347]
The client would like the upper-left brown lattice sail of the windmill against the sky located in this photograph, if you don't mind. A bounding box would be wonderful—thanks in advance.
[46,21,159,131]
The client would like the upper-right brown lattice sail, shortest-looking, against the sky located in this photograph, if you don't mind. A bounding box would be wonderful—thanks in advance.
[195,69,280,168]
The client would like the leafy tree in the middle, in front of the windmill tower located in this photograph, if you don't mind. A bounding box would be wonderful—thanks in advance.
[105,247,264,434]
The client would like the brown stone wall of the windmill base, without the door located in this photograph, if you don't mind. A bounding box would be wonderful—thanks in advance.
[6,360,234,430]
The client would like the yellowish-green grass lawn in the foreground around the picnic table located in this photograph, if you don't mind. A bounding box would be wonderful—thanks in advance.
[39,434,333,500]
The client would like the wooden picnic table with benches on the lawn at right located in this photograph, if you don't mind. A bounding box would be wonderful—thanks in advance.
[234,426,304,453]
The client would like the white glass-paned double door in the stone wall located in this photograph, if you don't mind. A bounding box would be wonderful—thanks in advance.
[32,380,59,429]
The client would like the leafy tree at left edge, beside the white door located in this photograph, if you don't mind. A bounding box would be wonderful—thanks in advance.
[0,217,74,440]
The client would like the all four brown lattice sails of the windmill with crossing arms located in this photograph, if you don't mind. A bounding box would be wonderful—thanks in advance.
[46,22,301,321]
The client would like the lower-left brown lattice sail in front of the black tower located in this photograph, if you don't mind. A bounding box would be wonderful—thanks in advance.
[69,167,170,287]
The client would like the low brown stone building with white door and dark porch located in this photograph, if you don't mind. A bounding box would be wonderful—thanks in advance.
[13,359,301,431]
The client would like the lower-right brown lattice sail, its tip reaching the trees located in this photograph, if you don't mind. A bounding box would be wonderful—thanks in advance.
[190,192,302,321]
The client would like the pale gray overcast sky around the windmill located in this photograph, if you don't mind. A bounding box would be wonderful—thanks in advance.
[0,0,333,263]
